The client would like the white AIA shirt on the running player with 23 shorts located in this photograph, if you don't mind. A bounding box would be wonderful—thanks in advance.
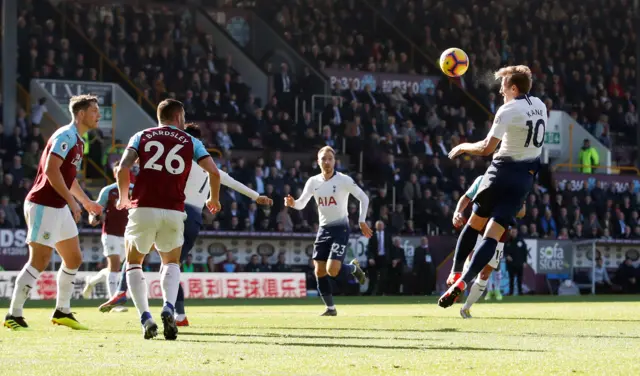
[294,172,369,226]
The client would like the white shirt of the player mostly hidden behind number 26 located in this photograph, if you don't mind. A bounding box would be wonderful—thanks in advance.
[184,161,260,209]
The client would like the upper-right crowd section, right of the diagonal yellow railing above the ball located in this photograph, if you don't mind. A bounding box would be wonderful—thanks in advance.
[376,0,637,164]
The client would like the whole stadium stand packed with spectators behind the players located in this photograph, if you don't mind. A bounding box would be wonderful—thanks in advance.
[7,0,640,290]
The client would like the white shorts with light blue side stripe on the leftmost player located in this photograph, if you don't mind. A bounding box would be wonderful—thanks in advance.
[24,201,78,248]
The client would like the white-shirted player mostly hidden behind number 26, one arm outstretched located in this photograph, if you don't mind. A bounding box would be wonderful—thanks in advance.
[100,124,273,326]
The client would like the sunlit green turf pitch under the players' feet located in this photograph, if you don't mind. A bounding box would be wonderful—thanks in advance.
[0,296,640,376]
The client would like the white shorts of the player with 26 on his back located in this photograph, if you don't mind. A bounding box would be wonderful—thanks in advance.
[124,208,187,255]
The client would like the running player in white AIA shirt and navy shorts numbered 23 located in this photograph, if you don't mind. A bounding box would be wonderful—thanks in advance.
[284,146,373,316]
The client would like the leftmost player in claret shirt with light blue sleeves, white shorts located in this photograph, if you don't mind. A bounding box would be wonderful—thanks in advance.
[4,95,102,330]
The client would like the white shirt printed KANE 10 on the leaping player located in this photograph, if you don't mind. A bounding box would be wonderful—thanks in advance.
[489,95,549,161]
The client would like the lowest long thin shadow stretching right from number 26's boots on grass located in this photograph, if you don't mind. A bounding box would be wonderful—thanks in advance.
[179,333,546,353]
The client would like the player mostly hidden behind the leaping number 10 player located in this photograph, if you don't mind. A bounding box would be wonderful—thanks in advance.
[453,175,526,319]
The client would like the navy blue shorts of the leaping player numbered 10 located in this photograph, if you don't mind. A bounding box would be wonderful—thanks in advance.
[473,160,540,228]
